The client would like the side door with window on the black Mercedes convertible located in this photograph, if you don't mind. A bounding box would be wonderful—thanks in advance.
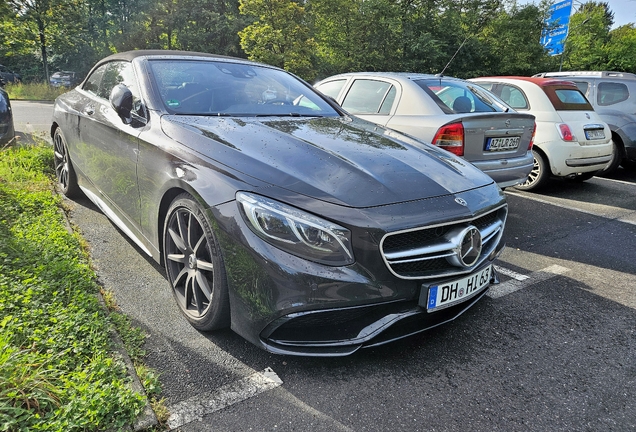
[79,61,145,227]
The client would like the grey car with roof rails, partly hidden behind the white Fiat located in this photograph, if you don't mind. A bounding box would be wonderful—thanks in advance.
[535,71,636,174]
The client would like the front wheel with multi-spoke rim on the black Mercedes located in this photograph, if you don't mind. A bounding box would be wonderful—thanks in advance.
[163,194,230,331]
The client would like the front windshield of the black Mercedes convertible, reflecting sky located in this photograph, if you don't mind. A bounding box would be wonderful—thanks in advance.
[150,60,339,117]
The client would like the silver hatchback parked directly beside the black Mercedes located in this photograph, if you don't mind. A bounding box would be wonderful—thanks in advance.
[315,73,535,188]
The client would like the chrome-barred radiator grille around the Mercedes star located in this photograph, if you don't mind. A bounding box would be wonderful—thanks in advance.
[380,206,508,279]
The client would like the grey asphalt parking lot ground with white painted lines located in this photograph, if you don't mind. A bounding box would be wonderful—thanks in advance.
[13,102,636,431]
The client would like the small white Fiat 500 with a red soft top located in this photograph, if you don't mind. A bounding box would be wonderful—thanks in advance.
[471,77,613,190]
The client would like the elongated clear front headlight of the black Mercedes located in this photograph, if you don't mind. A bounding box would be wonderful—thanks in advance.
[236,192,355,266]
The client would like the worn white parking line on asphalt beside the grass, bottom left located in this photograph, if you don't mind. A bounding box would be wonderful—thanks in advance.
[168,368,283,429]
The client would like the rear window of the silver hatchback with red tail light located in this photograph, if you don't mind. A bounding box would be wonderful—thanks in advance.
[415,78,508,114]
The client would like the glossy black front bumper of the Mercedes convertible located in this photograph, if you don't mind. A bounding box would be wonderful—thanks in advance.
[211,184,506,356]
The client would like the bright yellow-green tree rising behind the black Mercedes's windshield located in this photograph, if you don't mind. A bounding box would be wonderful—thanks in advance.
[239,0,316,80]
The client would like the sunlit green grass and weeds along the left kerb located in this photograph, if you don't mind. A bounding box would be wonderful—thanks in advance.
[0,145,145,431]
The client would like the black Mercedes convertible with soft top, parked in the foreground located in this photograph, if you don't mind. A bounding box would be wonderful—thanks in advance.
[51,51,507,356]
